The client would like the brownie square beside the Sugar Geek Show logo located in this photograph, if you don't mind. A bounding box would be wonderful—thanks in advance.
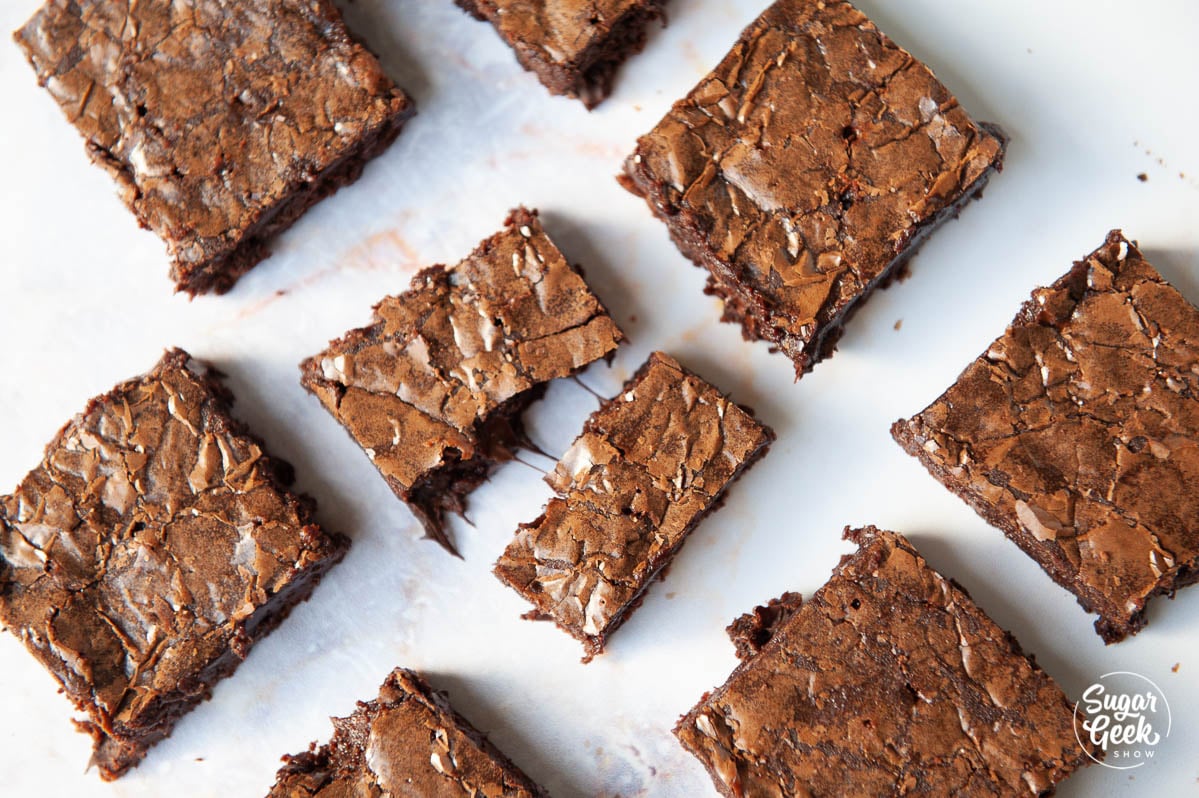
[675,527,1090,798]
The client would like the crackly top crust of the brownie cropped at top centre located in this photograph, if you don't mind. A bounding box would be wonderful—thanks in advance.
[476,0,647,66]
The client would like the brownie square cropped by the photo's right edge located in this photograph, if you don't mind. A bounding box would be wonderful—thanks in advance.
[891,231,1199,642]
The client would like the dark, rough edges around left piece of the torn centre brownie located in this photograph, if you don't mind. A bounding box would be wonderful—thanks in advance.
[300,206,625,558]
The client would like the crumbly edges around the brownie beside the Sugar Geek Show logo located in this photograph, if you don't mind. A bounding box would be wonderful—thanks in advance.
[671,525,1103,798]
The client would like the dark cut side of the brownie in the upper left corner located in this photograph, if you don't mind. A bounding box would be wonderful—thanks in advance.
[166,99,416,297]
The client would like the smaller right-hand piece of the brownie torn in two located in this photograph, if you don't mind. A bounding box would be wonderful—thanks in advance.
[495,352,775,661]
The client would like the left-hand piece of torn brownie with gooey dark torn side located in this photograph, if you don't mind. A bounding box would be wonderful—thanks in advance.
[301,208,623,554]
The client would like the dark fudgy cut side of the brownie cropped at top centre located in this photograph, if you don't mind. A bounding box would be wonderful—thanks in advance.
[454,0,667,110]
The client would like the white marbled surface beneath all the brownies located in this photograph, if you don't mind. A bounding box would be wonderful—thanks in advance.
[0,0,1199,798]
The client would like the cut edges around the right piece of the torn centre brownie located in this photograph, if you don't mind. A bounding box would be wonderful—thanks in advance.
[492,351,777,664]
